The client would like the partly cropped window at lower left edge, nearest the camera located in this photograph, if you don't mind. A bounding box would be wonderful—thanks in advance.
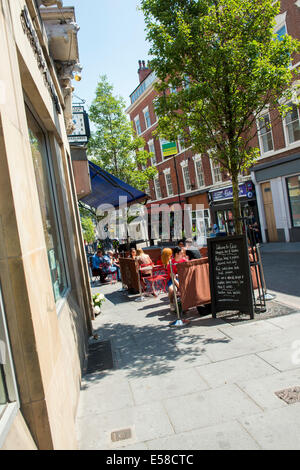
[0,286,19,447]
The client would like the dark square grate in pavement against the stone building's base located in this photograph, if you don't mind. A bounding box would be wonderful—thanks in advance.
[86,341,114,374]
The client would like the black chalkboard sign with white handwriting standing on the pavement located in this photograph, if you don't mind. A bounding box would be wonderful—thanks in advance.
[207,235,254,318]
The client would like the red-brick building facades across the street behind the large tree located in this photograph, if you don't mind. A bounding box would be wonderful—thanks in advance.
[127,0,300,246]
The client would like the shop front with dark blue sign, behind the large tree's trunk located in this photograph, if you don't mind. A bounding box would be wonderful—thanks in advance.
[209,181,260,238]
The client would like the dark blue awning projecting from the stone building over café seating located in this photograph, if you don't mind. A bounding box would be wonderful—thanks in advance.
[81,162,148,209]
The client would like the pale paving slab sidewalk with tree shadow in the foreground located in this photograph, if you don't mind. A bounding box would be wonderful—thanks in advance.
[77,284,300,451]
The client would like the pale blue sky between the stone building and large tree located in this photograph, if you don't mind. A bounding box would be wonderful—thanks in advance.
[64,0,149,107]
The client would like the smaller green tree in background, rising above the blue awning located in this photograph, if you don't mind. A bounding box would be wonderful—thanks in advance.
[88,75,157,191]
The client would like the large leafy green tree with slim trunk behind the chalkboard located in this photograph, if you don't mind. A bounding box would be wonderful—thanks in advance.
[141,0,300,233]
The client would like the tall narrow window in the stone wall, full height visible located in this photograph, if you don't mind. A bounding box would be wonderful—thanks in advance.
[27,109,68,302]
